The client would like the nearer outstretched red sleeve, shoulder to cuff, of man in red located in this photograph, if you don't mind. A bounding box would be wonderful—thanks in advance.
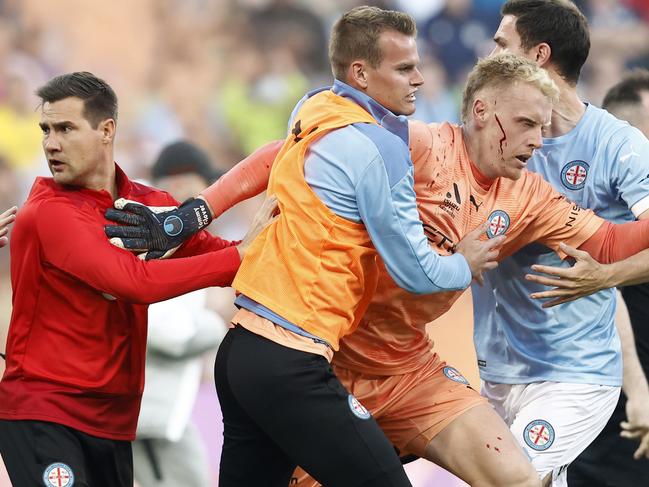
[38,203,240,304]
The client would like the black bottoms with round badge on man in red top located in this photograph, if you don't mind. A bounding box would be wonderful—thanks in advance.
[0,420,133,487]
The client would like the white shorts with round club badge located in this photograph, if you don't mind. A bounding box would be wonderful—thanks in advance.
[481,381,620,487]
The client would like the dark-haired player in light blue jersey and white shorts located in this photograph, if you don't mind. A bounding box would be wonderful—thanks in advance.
[472,0,649,486]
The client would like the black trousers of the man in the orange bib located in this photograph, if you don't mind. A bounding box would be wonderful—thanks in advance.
[214,326,410,487]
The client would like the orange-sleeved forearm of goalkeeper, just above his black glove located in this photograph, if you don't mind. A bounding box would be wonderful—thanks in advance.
[198,140,284,218]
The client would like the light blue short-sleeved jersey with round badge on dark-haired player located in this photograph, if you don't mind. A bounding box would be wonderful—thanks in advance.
[472,105,649,386]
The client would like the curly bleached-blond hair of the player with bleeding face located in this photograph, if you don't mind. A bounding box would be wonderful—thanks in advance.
[462,53,559,123]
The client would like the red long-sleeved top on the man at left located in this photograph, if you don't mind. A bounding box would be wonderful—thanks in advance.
[0,168,240,440]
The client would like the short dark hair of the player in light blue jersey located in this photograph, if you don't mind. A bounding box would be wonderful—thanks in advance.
[500,0,590,85]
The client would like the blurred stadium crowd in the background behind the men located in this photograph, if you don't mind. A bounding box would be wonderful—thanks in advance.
[0,0,649,486]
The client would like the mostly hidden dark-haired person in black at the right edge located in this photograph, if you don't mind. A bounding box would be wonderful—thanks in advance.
[568,70,649,487]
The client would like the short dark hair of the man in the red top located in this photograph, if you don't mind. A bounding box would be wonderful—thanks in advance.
[36,71,117,128]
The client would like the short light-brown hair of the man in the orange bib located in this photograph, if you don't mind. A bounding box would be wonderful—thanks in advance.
[329,6,417,81]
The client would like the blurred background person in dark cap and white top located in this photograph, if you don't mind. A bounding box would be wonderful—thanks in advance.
[133,141,227,487]
